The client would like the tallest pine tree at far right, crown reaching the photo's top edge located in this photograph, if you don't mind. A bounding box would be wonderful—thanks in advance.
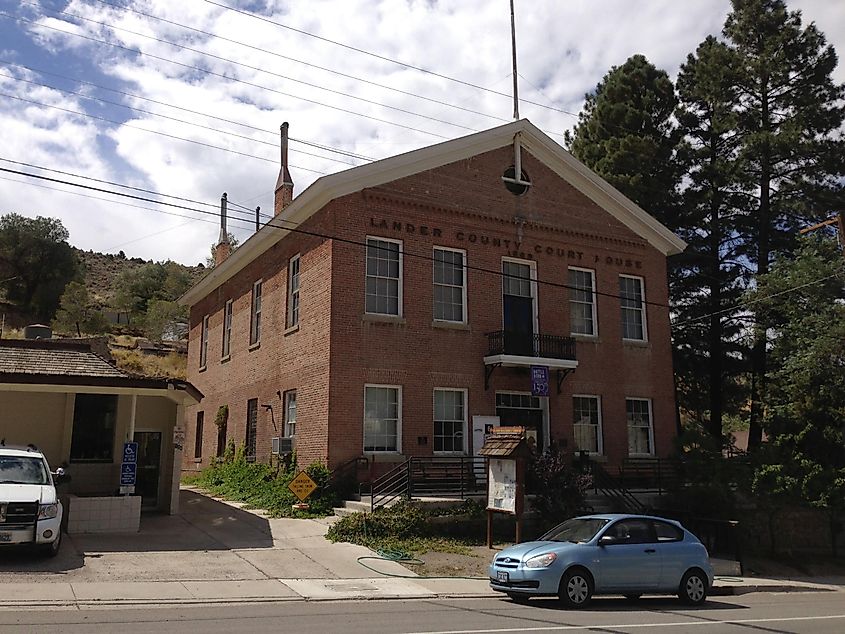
[723,0,845,448]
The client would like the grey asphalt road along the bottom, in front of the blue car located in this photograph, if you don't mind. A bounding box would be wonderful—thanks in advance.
[0,592,845,634]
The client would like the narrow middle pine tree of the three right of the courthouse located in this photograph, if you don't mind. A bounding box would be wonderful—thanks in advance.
[671,36,749,440]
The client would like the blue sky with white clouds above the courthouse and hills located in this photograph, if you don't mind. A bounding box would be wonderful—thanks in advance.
[0,0,845,264]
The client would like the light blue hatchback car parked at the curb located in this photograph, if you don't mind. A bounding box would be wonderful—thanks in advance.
[489,514,713,608]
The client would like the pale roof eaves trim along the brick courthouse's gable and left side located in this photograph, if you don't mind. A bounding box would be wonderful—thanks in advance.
[179,119,686,306]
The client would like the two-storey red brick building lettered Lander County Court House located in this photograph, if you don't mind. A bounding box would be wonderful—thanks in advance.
[183,120,685,476]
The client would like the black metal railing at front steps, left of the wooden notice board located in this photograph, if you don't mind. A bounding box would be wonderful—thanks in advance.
[370,456,487,511]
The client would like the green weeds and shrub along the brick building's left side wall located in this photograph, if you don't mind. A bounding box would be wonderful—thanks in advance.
[187,442,337,518]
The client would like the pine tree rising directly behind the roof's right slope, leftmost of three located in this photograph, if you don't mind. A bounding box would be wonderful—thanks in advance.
[565,55,679,228]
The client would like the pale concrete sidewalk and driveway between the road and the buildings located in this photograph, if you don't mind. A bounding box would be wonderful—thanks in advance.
[0,489,845,610]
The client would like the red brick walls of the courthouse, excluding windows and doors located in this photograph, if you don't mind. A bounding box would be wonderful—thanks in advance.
[181,142,675,468]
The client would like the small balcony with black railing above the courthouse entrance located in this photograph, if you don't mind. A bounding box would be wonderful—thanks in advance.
[484,330,578,393]
